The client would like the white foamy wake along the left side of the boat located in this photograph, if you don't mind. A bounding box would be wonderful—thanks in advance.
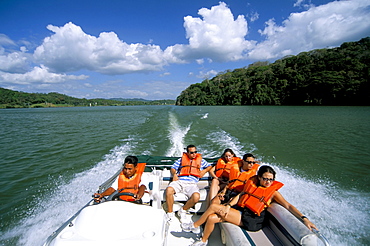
[1,143,134,246]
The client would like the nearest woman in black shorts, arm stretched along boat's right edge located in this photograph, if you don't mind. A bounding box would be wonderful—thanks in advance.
[181,166,317,246]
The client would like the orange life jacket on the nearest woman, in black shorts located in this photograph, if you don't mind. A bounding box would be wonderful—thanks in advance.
[238,180,284,216]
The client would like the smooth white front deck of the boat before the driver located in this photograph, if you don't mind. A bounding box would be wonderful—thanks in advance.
[47,201,166,246]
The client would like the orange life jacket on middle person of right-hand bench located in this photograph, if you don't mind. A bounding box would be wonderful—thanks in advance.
[227,164,260,193]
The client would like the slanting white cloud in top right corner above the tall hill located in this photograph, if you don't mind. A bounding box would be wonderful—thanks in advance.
[248,0,370,60]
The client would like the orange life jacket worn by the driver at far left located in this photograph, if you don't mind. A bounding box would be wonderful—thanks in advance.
[118,163,146,201]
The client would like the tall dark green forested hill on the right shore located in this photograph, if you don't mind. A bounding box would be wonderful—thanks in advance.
[176,37,370,105]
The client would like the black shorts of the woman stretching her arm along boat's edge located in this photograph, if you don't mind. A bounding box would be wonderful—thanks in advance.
[233,206,266,231]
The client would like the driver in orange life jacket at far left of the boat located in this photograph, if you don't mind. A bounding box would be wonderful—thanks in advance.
[94,156,148,203]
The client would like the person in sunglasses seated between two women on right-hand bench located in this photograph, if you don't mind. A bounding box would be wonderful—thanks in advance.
[211,153,260,204]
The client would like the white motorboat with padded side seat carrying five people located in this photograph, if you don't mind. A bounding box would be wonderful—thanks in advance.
[44,155,330,246]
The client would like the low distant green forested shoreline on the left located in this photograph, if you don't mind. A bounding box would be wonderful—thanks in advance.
[0,88,175,108]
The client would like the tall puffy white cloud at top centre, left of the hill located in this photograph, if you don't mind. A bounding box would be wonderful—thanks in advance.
[165,2,255,62]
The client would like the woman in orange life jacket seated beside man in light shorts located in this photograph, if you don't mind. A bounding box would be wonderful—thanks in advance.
[208,149,241,207]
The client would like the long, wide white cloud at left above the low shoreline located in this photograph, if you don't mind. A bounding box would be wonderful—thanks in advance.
[34,22,166,74]
